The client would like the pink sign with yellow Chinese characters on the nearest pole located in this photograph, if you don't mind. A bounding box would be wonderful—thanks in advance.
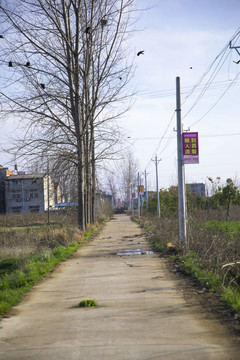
[182,132,199,164]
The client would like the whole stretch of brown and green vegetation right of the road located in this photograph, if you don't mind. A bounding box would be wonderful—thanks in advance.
[137,214,240,313]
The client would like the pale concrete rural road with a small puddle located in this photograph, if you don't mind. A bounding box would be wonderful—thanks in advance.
[0,214,240,360]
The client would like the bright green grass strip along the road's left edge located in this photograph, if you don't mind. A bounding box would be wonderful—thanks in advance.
[0,221,105,319]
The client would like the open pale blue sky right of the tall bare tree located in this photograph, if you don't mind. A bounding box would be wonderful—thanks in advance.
[121,0,240,190]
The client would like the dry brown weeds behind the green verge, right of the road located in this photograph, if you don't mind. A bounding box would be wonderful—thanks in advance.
[141,208,240,284]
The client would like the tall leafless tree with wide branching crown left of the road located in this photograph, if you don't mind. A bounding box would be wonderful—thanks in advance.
[0,0,137,230]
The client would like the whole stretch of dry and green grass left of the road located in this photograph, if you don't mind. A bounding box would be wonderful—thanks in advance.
[0,219,107,319]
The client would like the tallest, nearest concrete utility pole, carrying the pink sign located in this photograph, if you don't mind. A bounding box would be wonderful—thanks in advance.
[176,77,187,248]
